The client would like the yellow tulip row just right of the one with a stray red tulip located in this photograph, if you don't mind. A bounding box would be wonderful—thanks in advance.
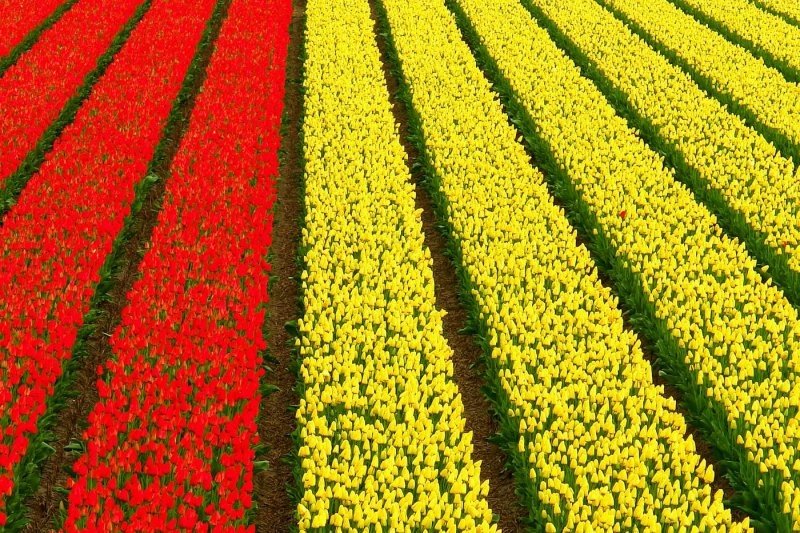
[530,0,800,271]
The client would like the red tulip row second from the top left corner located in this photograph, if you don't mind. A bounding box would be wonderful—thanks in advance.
[0,0,143,186]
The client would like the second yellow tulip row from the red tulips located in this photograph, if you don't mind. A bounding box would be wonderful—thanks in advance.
[382,0,744,531]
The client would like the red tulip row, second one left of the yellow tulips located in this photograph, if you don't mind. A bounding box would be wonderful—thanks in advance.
[0,0,216,523]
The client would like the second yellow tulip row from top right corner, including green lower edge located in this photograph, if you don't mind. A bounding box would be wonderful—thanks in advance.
[675,0,800,81]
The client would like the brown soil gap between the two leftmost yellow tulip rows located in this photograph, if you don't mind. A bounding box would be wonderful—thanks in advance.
[369,0,527,531]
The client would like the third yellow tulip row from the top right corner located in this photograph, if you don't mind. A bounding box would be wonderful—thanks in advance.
[599,0,800,152]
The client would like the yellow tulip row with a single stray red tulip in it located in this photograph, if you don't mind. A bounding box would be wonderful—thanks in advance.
[458,0,800,528]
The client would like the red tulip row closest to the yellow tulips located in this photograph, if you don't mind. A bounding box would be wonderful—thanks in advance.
[66,0,291,531]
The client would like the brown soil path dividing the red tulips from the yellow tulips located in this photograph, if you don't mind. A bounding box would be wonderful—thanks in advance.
[254,0,306,533]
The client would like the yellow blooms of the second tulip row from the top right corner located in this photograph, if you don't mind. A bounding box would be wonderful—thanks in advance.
[682,0,800,73]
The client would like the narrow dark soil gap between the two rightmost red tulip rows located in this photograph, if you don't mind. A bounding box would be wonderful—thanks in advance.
[26,0,232,532]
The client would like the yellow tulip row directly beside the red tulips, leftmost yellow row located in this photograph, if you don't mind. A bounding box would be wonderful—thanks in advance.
[296,0,496,531]
